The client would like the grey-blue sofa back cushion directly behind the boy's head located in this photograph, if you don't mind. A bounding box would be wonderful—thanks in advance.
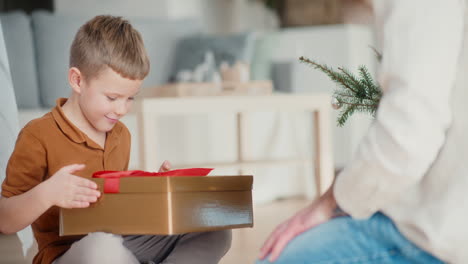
[32,11,200,107]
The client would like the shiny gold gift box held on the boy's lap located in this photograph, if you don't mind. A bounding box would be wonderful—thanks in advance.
[60,176,253,236]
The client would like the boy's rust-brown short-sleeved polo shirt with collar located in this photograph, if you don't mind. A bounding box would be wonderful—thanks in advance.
[2,98,130,264]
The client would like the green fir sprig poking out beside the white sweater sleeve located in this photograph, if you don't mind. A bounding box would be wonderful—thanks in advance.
[299,55,382,126]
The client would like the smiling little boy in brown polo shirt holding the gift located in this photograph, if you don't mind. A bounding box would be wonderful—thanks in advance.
[0,16,231,264]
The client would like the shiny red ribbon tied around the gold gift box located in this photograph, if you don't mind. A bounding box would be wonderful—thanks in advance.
[93,168,213,193]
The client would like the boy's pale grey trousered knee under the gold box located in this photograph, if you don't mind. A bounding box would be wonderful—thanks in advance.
[72,232,138,263]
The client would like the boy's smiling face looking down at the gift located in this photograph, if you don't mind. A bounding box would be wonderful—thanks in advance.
[74,67,142,132]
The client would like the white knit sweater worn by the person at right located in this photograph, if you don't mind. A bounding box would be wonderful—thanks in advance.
[334,0,468,263]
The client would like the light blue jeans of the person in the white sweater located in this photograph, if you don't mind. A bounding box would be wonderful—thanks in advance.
[257,213,443,264]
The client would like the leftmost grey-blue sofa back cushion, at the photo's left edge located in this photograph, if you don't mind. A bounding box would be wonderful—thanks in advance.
[0,11,40,108]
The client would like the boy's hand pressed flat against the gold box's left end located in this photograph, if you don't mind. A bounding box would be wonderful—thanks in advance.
[44,164,101,208]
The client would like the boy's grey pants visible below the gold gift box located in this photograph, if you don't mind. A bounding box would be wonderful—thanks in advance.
[53,230,231,264]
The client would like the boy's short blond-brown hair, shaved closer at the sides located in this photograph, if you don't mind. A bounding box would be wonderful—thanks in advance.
[70,15,150,80]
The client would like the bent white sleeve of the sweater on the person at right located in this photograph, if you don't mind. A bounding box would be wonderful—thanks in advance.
[334,0,464,218]
